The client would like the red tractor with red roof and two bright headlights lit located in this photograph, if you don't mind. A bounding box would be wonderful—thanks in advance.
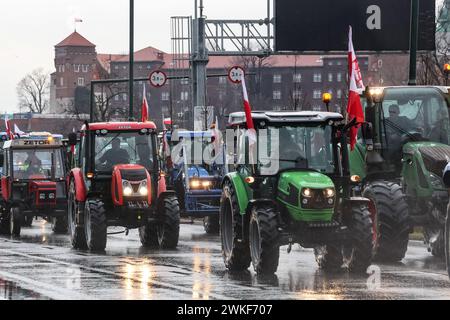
[68,122,180,251]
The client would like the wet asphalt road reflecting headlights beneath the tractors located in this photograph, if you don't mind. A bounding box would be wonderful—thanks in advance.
[0,221,450,300]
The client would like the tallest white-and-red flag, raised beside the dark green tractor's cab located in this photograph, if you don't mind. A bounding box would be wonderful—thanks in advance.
[347,26,365,150]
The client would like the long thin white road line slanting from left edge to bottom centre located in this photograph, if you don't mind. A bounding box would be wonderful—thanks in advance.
[0,249,233,300]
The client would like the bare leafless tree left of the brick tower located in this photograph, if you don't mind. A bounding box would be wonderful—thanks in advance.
[17,68,50,113]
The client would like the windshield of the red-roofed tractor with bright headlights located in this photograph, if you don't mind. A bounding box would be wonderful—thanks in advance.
[94,132,153,173]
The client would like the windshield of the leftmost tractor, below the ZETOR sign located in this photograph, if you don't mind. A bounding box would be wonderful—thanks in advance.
[12,149,64,180]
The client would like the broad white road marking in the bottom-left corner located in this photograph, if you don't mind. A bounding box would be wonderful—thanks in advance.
[0,271,96,300]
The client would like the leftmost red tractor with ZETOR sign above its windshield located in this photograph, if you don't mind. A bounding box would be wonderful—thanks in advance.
[1,133,67,236]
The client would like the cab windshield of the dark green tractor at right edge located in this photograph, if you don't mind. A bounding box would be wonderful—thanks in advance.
[380,88,450,158]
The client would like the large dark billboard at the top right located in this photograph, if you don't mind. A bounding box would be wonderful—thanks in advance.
[275,0,436,51]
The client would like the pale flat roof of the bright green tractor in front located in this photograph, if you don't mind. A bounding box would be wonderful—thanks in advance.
[229,111,344,125]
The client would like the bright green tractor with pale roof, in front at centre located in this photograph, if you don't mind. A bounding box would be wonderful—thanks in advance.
[220,111,373,274]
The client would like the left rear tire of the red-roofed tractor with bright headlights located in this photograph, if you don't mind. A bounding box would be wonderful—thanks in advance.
[67,181,87,250]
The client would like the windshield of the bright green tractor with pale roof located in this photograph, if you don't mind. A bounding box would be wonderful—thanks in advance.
[260,126,335,174]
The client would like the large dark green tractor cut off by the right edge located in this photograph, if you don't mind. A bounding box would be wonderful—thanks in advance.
[350,86,450,262]
